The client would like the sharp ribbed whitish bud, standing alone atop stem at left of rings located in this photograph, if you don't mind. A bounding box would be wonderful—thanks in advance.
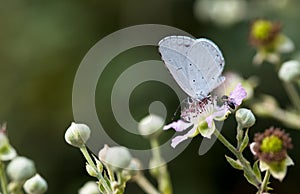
[65,122,91,148]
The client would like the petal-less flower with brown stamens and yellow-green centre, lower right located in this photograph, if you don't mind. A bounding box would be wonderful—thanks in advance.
[250,127,294,181]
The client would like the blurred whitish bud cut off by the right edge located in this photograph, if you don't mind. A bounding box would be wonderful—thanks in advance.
[278,60,300,82]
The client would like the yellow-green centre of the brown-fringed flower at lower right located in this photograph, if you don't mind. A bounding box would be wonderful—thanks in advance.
[260,135,283,153]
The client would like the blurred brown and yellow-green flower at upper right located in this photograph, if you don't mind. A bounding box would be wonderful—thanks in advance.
[249,19,294,64]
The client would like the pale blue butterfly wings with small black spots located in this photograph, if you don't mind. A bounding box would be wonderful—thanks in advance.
[159,36,225,100]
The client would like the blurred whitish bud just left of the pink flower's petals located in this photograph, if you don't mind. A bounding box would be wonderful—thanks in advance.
[138,114,164,138]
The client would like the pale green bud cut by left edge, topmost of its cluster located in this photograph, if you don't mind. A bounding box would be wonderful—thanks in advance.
[0,132,17,161]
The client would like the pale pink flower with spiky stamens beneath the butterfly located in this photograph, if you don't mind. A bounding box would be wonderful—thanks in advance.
[163,84,247,148]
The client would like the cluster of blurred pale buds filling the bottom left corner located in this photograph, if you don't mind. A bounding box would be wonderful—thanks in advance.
[0,124,48,194]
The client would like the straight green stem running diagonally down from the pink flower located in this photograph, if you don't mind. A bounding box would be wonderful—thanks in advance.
[214,130,260,188]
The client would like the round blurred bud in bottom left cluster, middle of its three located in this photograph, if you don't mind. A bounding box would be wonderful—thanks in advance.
[7,156,36,181]
